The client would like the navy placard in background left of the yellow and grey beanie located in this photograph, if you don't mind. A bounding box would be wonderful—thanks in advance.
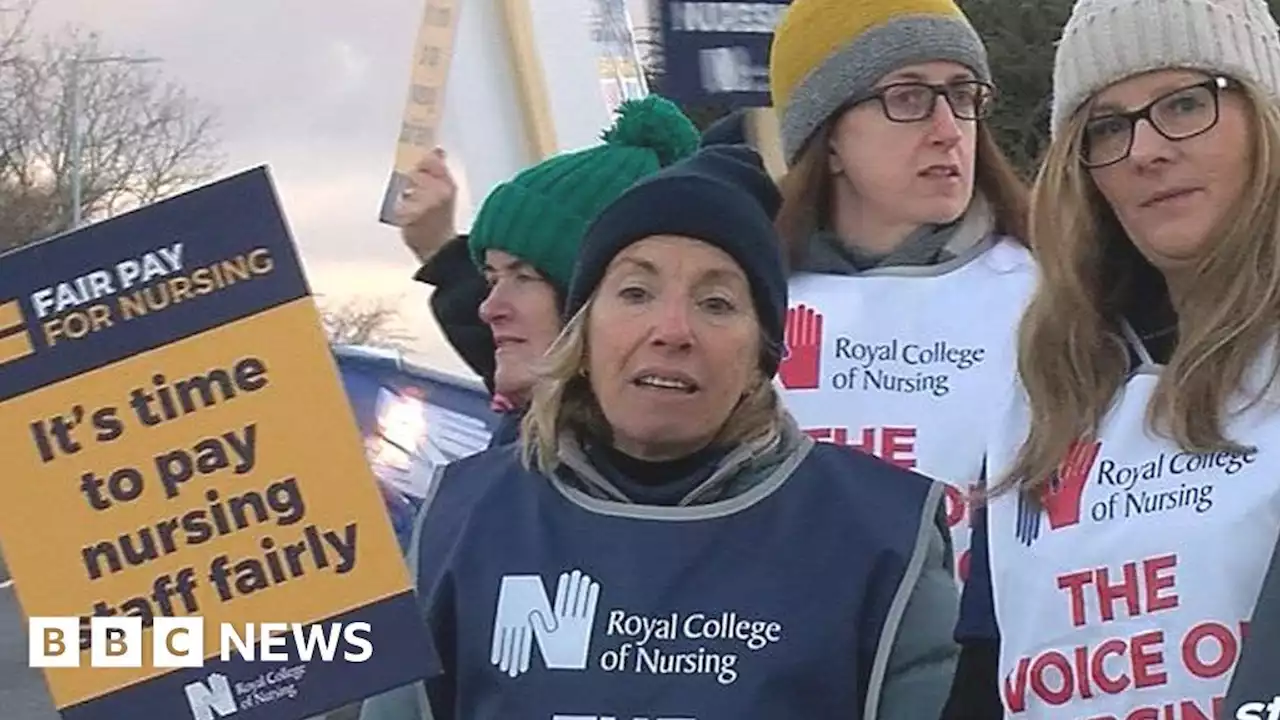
[660,0,790,108]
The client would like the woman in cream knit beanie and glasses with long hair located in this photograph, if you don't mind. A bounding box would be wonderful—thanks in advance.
[957,0,1280,720]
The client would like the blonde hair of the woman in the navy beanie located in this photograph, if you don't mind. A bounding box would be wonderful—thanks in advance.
[520,293,785,474]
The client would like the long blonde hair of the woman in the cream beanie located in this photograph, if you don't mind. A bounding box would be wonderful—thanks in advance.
[989,75,1280,498]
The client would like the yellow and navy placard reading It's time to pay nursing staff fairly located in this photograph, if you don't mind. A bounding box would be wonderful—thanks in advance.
[0,168,433,720]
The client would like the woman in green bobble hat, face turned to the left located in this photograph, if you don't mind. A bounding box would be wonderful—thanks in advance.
[404,95,699,445]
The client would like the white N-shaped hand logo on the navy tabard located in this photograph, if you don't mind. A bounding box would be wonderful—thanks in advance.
[489,570,600,678]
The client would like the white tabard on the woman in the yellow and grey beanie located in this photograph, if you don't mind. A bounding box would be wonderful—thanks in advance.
[778,238,1036,579]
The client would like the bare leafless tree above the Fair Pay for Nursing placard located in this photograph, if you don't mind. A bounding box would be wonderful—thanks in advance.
[0,23,224,250]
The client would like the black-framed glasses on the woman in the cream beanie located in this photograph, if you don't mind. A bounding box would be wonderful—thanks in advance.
[1080,77,1233,169]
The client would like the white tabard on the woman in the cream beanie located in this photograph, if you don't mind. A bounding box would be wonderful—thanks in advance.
[988,333,1280,720]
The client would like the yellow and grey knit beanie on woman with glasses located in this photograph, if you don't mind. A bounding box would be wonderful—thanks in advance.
[769,0,991,163]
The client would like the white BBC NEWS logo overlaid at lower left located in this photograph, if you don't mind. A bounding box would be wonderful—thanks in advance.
[28,616,374,667]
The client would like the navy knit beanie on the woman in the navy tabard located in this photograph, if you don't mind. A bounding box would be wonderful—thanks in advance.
[564,145,787,378]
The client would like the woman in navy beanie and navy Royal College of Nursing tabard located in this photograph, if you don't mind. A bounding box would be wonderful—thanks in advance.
[365,146,957,720]
